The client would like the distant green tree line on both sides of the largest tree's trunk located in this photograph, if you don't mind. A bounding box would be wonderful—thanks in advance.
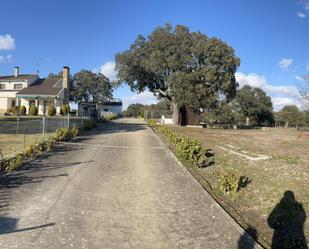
[124,85,309,127]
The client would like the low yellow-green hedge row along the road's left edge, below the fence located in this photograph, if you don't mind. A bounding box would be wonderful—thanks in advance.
[0,127,79,172]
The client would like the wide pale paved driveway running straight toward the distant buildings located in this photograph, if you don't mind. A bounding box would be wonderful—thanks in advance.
[0,119,260,249]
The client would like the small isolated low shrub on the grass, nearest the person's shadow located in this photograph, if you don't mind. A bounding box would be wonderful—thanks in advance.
[214,170,251,195]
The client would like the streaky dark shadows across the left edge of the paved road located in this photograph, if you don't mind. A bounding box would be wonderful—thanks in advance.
[0,146,93,236]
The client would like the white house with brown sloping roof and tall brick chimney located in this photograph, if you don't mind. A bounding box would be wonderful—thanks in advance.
[0,67,70,115]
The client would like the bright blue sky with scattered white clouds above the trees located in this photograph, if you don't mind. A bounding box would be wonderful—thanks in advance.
[0,0,309,109]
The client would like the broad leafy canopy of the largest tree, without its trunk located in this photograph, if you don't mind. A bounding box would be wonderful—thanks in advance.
[116,24,240,123]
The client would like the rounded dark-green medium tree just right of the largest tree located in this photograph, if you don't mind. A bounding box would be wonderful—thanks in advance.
[233,85,274,125]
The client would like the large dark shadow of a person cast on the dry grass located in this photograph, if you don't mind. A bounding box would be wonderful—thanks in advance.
[268,191,308,249]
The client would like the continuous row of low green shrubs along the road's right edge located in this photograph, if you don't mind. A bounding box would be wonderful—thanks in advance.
[148,120,214,168]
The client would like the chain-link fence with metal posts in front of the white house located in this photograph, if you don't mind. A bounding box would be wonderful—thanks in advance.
[0,116,89,157]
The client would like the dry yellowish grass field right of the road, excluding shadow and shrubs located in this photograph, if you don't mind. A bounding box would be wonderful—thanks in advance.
[173,128,309,247]
